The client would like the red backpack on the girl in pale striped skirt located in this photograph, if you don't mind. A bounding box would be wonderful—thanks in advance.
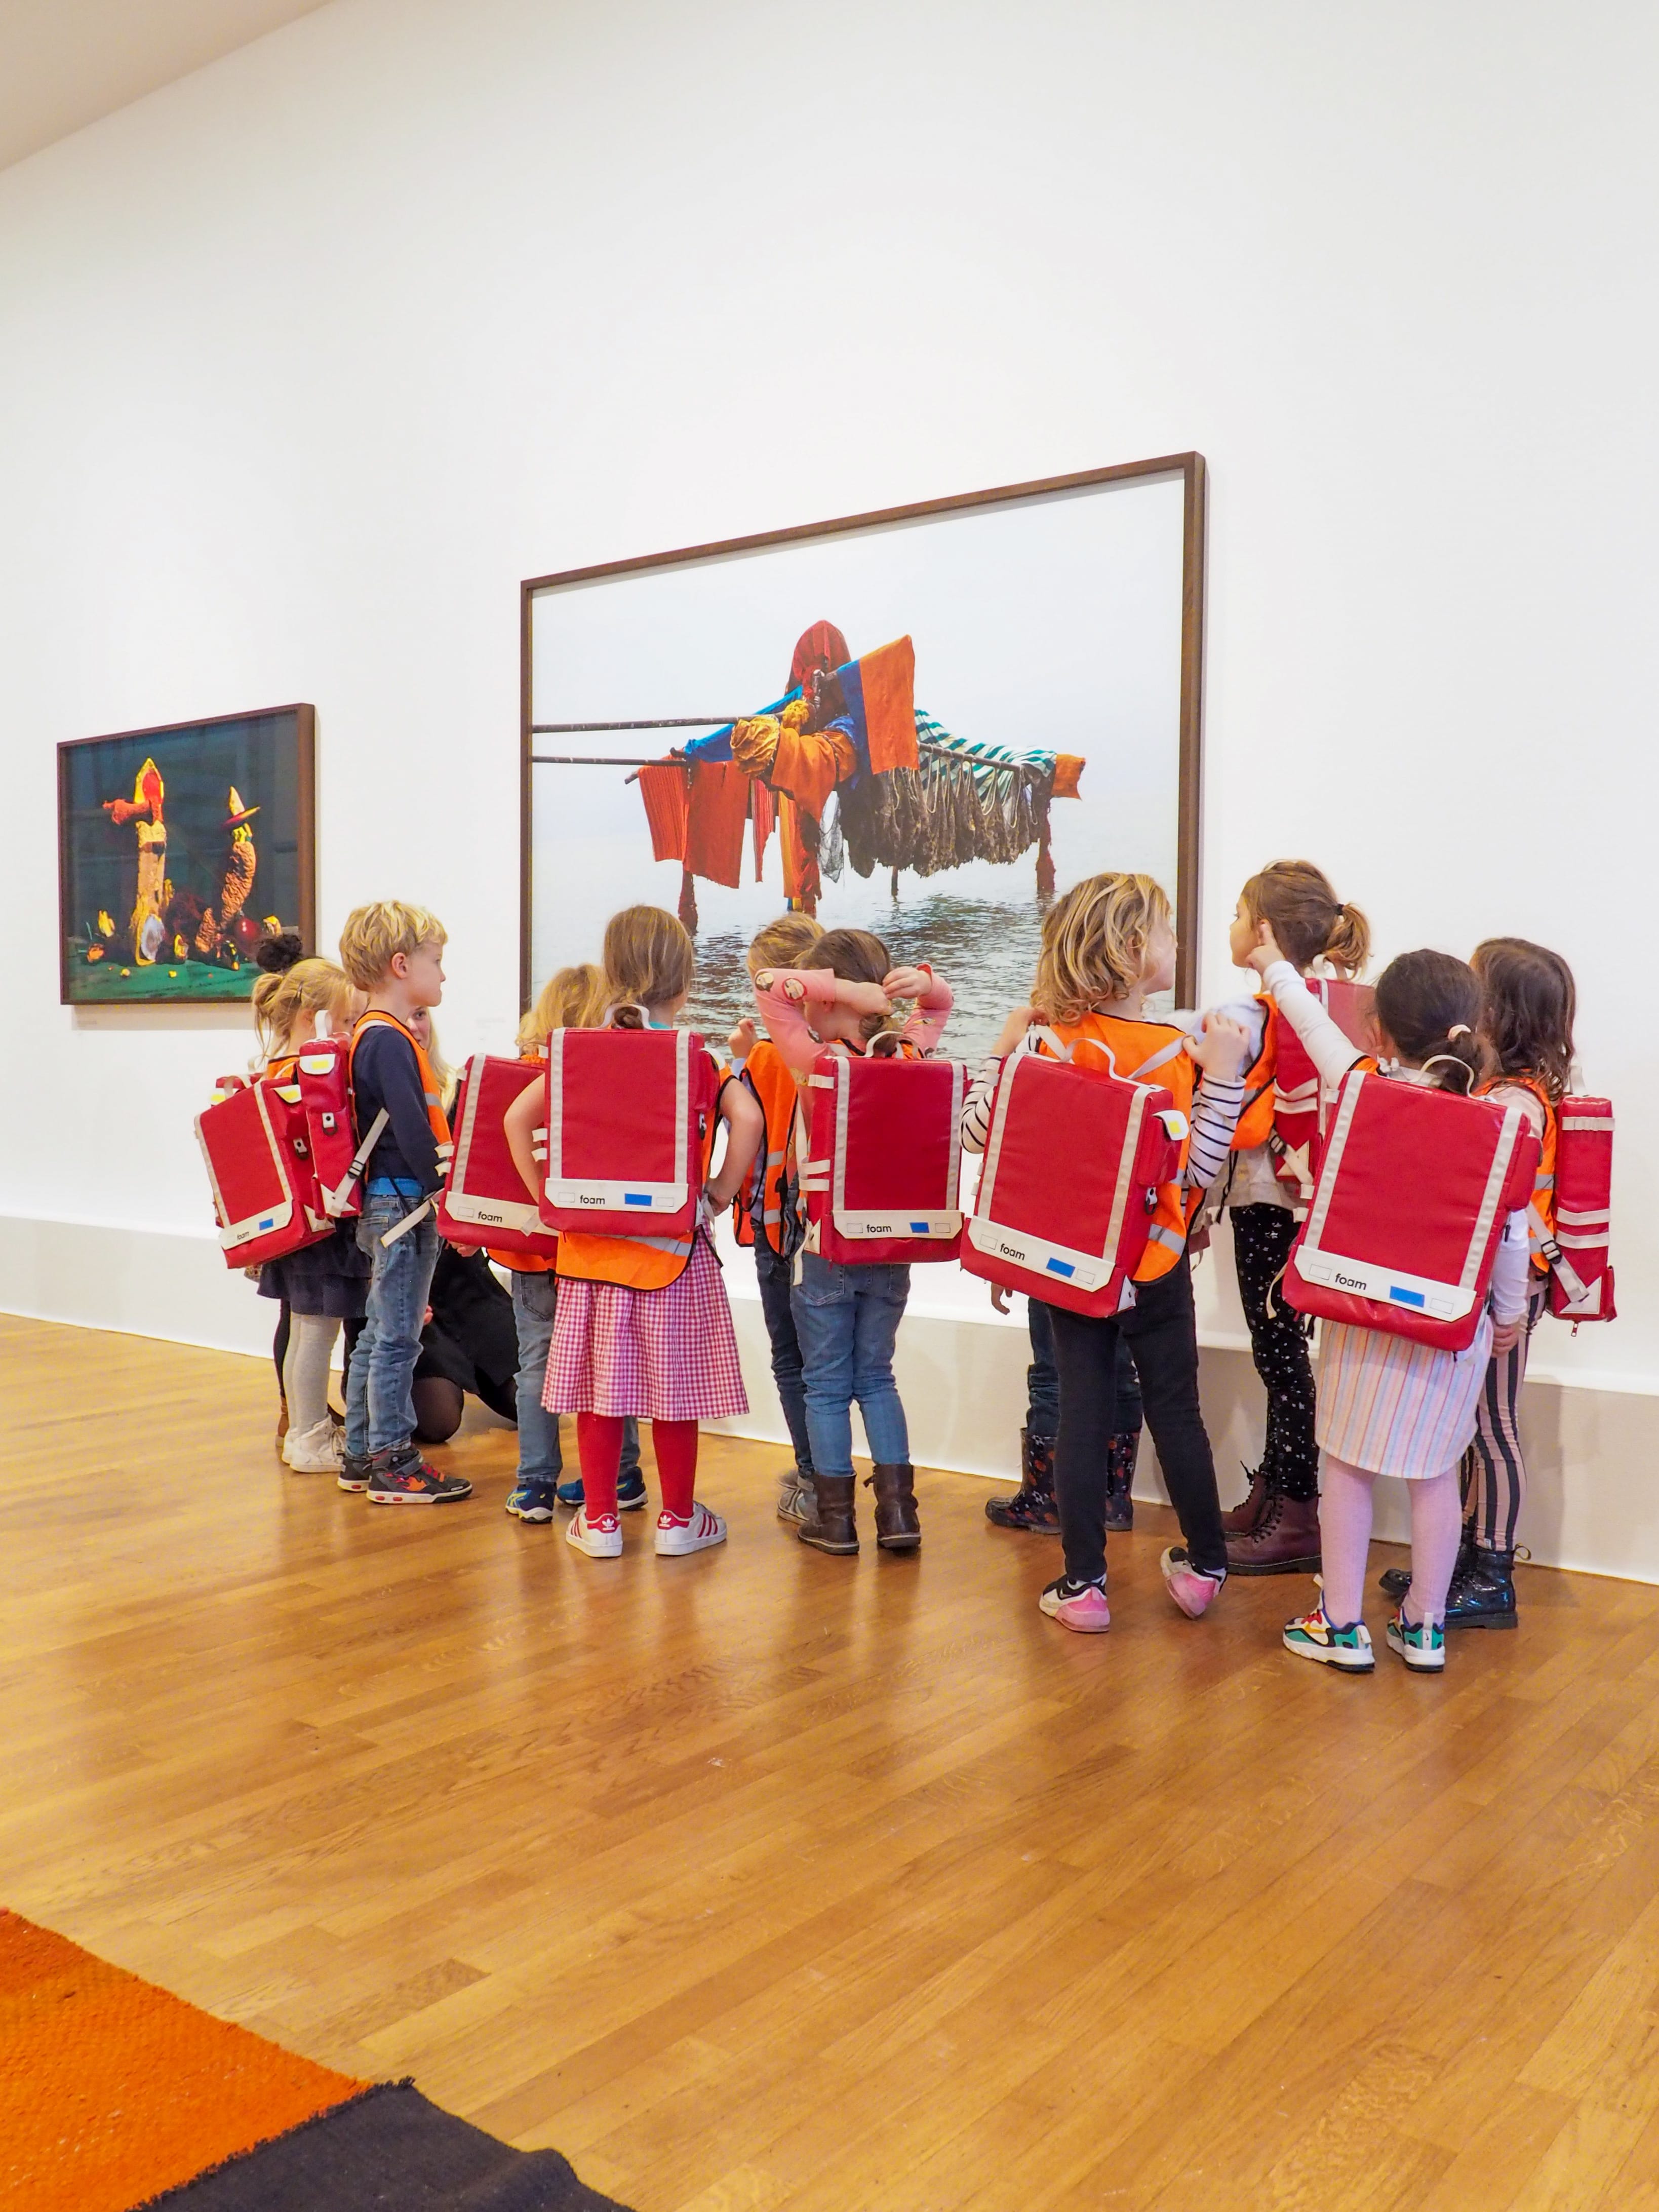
[1283,1068,1539,1351]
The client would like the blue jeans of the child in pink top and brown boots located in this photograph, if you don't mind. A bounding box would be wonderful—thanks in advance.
[789,1252,909,1476]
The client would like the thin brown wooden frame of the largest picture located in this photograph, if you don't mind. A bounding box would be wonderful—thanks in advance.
[520,453,1208,1006]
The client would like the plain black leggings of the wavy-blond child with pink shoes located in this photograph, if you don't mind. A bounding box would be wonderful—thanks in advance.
[1048,1252,1228,1581]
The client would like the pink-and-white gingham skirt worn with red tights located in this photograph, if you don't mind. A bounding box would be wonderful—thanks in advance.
[542,1234,750,1420]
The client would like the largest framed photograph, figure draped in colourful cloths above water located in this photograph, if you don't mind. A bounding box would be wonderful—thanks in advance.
[522,453,1206,1060]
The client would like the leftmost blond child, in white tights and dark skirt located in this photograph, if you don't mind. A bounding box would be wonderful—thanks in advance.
[252,936,369,1476]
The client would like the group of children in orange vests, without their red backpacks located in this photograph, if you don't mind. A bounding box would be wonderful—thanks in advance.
[254,863,1573,1672]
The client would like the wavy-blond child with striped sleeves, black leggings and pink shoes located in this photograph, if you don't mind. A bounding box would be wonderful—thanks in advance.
[962,874,1250,1635]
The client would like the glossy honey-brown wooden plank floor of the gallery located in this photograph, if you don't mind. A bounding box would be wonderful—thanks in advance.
[0,1321,1659,2212]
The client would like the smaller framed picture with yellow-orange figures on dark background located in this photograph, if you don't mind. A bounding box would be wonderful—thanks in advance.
[58,706,317,1006]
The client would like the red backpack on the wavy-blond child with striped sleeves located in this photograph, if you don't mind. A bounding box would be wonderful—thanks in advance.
[962,1037,1188,1314]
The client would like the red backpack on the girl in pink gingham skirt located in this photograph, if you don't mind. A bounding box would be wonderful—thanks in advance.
[537,1029,719,1236]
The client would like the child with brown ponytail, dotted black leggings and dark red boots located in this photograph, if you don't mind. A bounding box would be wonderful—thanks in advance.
[1221,861,1371,1575]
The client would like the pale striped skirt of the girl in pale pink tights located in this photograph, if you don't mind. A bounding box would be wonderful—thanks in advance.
[1314,1312,1491,1482]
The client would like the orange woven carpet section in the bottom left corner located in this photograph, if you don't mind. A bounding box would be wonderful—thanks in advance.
[0,1911,367,2212]
